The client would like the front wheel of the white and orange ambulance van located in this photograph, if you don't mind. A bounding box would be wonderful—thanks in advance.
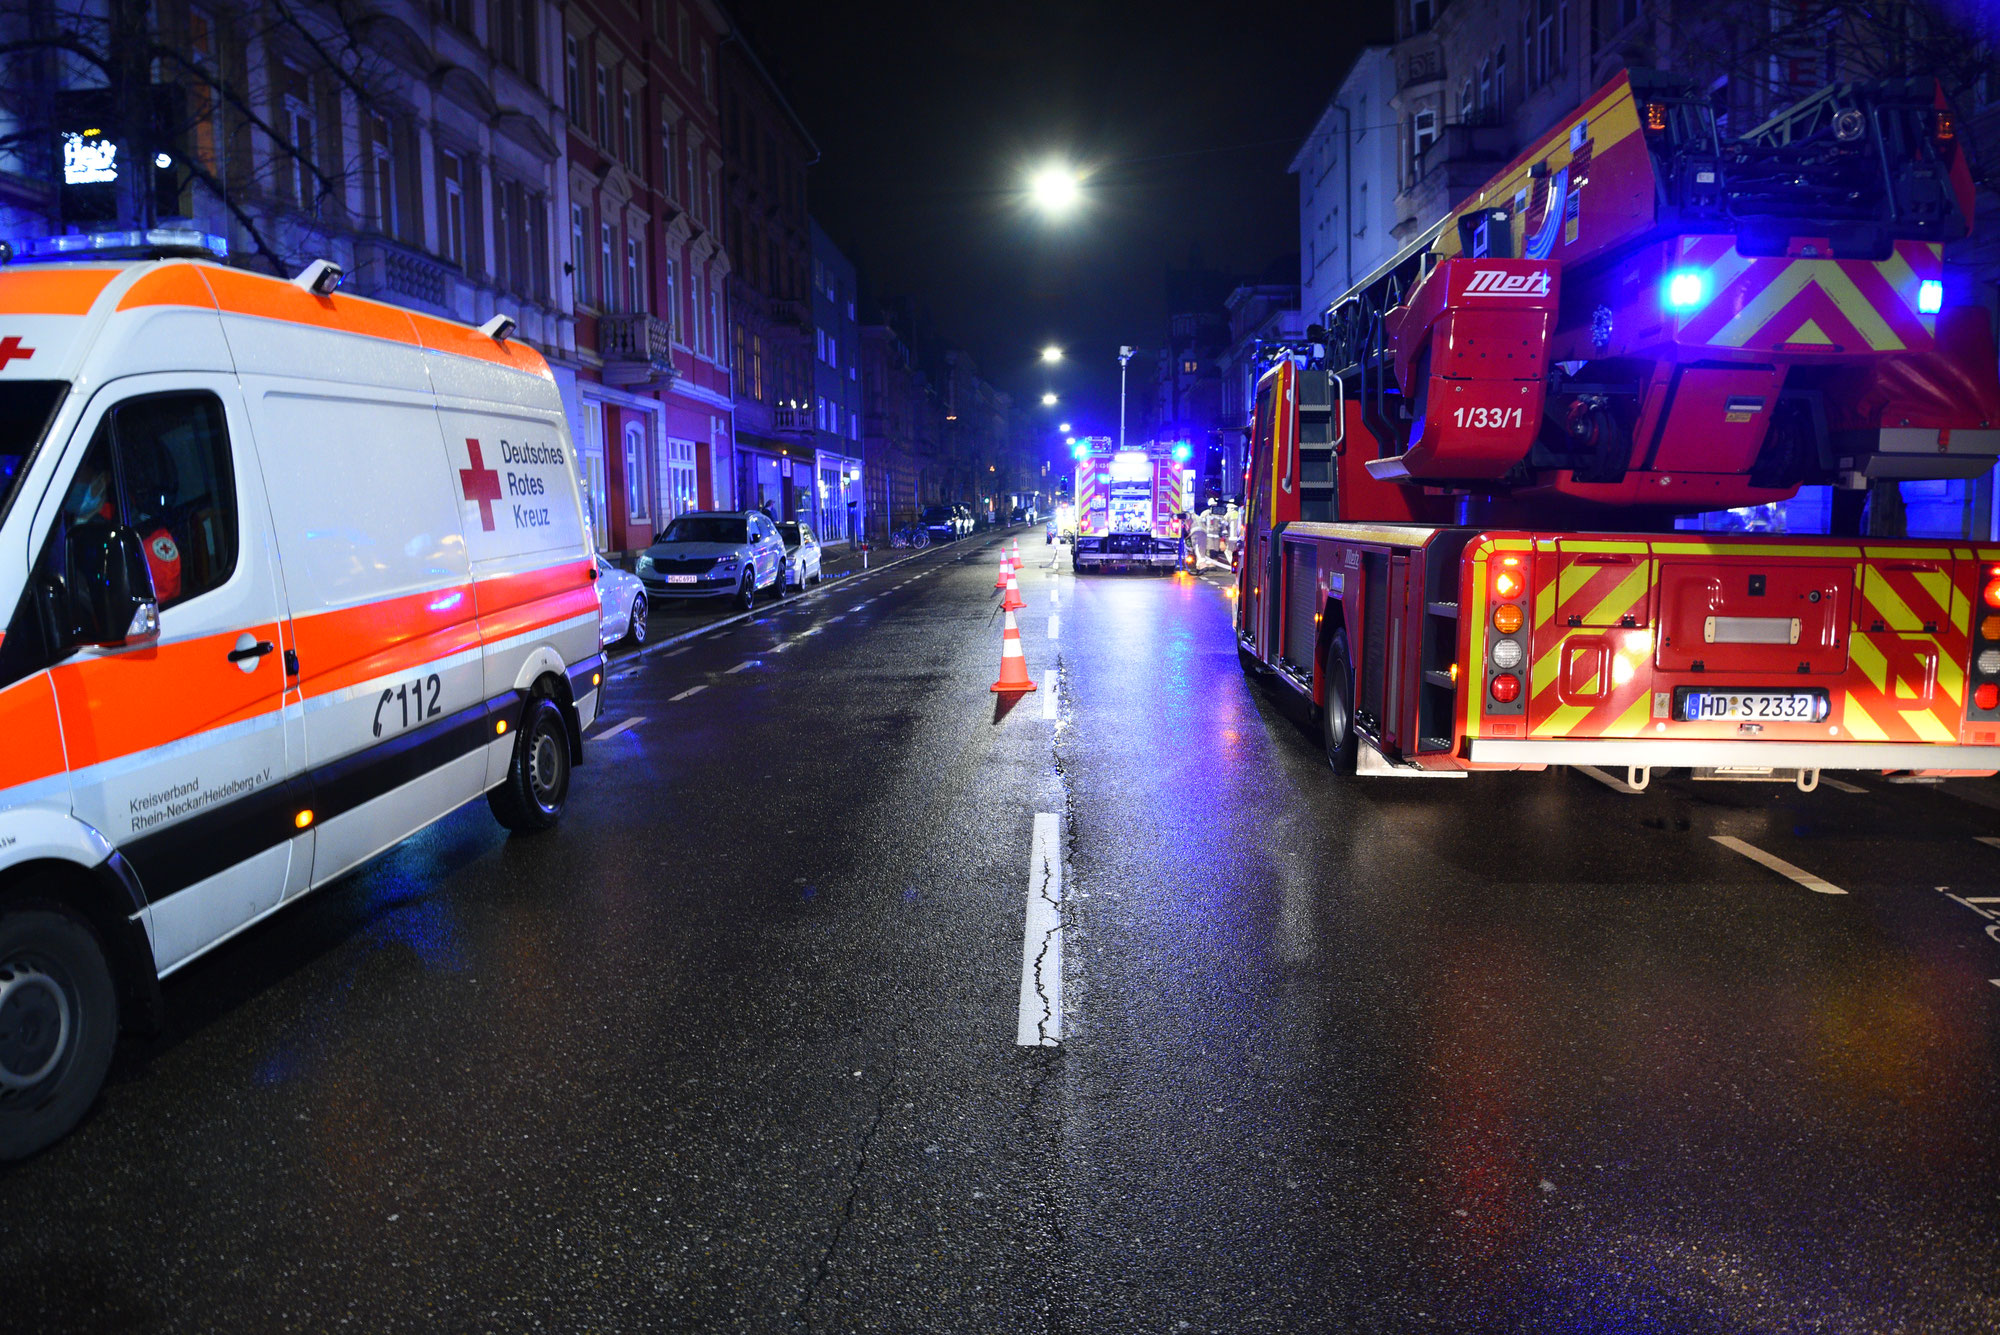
[0,905,118,1159]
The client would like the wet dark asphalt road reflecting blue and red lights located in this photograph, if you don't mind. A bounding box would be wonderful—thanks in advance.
[0,534,2000,1333]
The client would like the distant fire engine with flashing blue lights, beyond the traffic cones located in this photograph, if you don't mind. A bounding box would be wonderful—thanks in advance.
[1070,436,1192,574]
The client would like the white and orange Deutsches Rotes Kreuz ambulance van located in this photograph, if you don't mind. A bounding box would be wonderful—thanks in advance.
[0,249,604,1157]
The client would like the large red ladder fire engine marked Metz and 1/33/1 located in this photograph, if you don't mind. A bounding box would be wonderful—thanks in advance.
[1236,70,2000,787]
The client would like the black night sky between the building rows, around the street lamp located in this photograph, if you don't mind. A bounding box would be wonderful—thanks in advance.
[728,0,1390,447]
